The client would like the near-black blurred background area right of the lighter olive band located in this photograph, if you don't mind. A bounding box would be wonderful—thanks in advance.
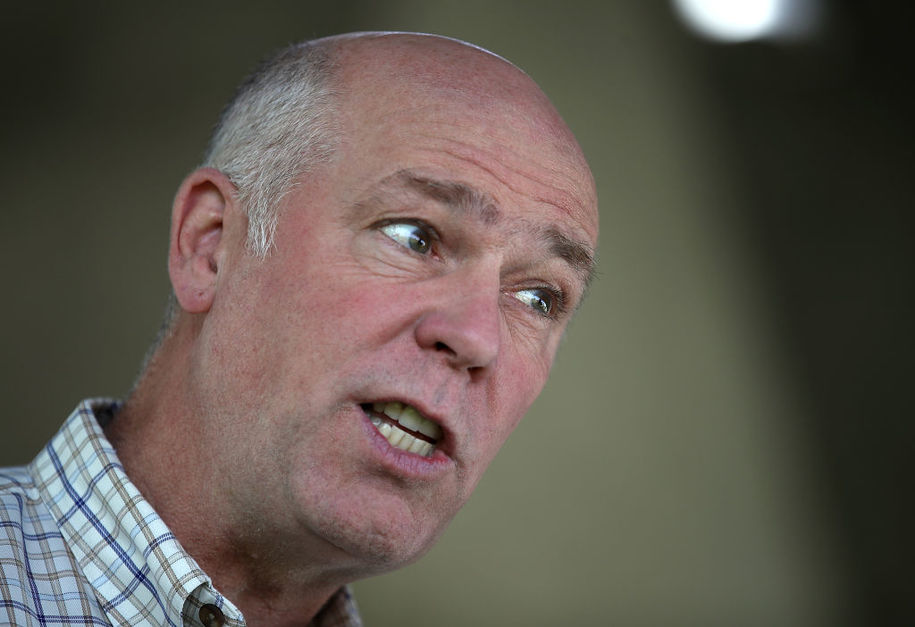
[703,2,915,625]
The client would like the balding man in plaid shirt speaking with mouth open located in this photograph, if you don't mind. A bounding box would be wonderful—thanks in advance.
[0,33,597,625]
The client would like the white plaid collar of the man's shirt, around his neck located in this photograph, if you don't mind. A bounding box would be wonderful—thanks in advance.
[31,399,361,627]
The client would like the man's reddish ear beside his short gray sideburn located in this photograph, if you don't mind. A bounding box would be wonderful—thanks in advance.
[168,168,236,313]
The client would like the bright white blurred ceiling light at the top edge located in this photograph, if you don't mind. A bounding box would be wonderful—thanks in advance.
[673,0,817,43]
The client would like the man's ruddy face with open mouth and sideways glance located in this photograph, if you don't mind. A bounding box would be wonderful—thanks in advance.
[192,41,597,570]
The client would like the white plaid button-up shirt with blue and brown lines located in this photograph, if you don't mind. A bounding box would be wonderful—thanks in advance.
[0,400,362,627]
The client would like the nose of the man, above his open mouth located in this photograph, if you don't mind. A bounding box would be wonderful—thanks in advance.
[415,268,502,373]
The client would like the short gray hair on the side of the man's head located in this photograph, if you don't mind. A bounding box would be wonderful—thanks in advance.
[203,42,336,257]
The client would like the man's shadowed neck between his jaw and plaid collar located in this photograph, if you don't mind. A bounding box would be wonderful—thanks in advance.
[105,322,358,625]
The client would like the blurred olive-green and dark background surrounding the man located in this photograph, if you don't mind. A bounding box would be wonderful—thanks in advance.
[0,0,915,626]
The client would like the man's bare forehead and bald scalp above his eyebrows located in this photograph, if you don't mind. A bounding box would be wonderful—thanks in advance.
[330,33,597,246]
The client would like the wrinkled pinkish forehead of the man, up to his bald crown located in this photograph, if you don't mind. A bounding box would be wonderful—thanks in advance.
[326,35,597,242]
